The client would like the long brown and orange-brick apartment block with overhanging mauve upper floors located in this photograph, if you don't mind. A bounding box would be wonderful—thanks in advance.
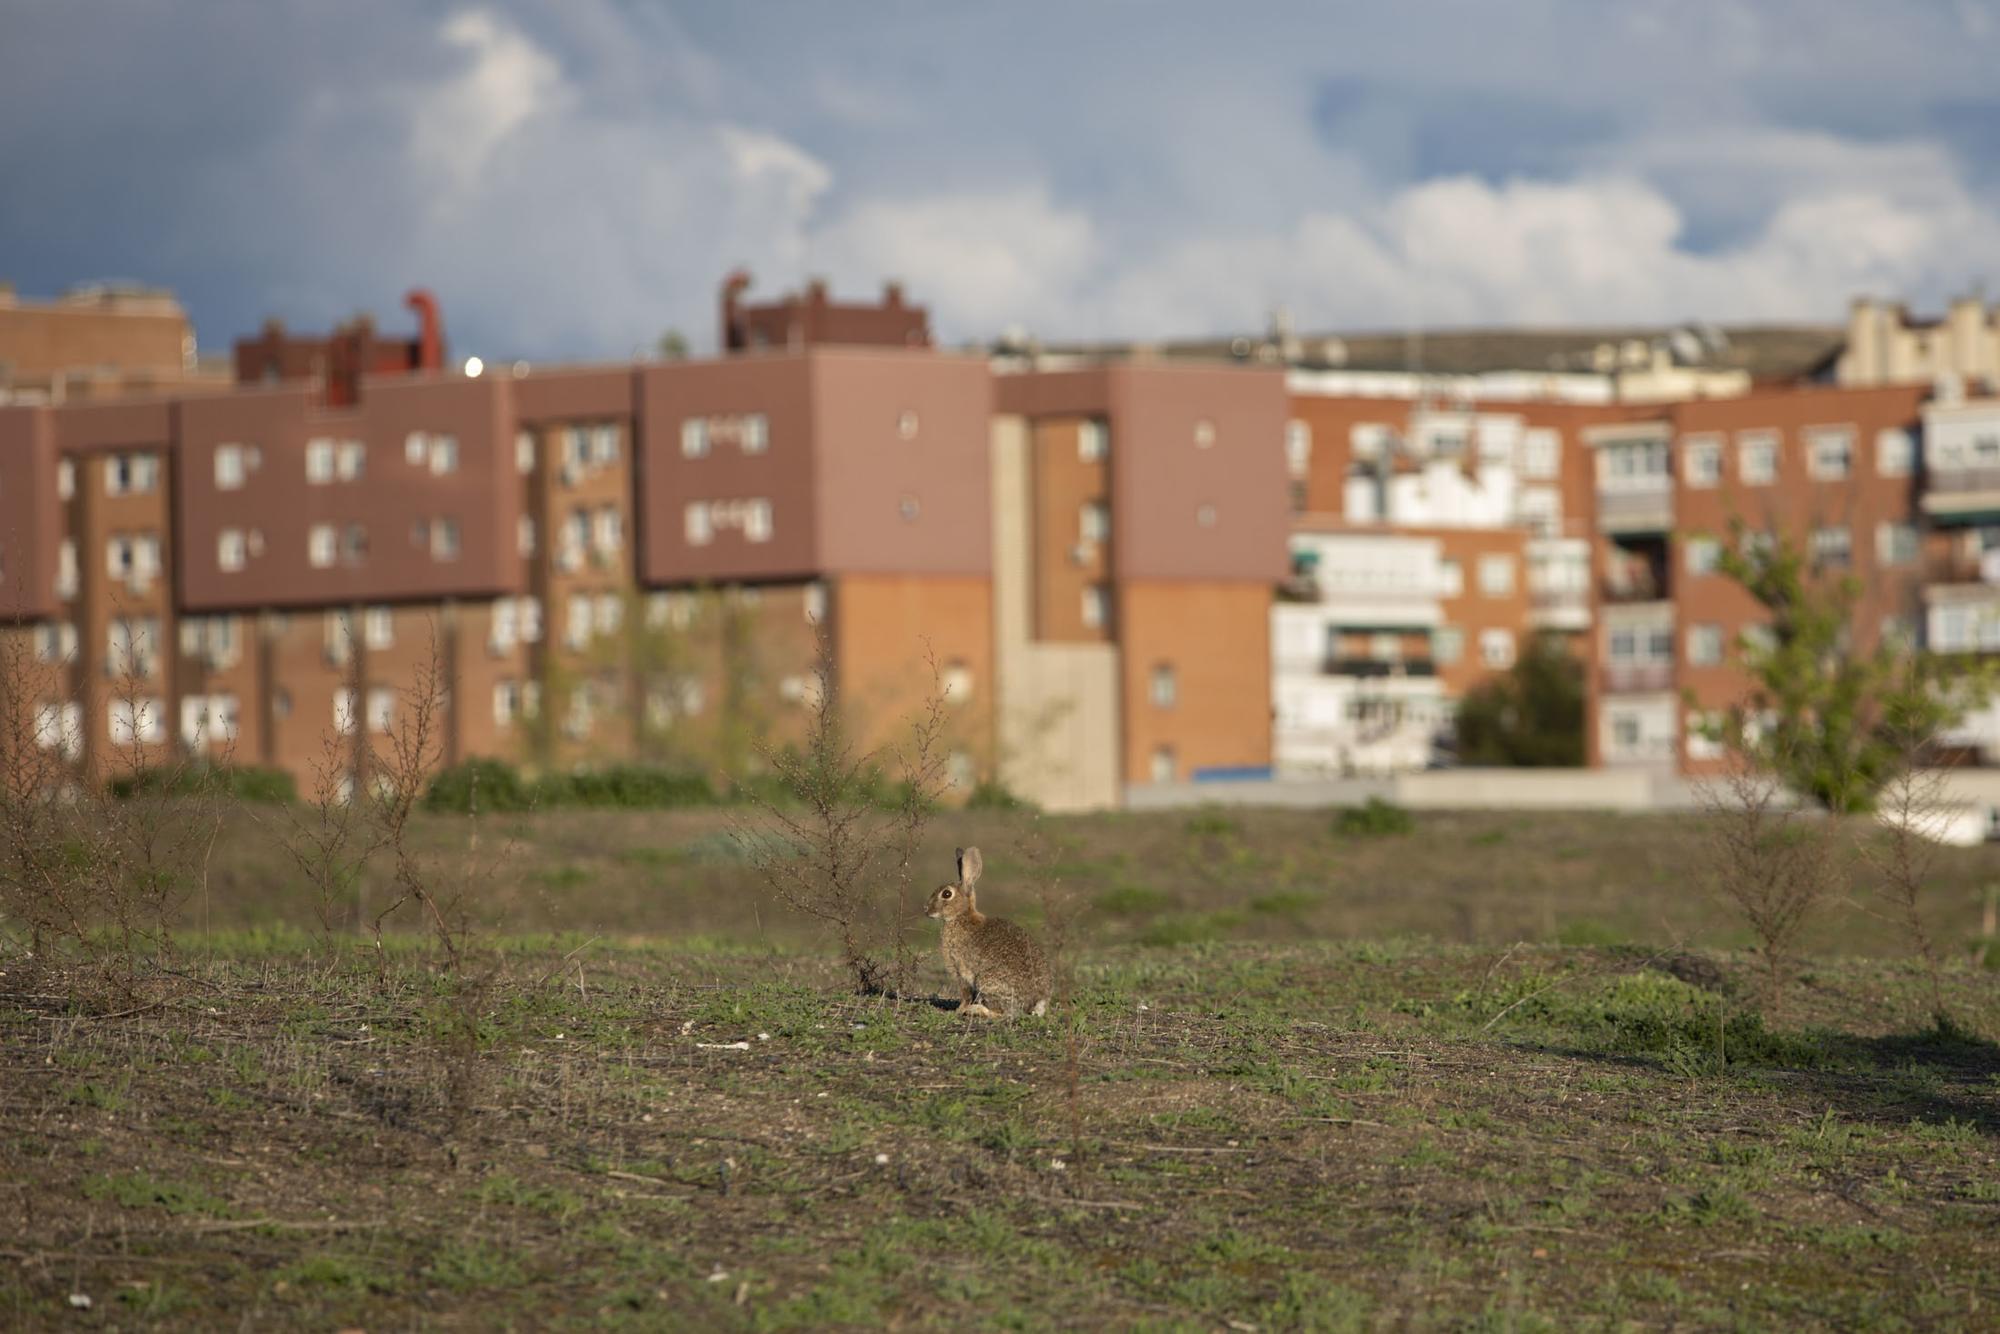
[0,336,1284,804]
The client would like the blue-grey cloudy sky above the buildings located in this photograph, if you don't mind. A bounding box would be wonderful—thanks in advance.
[0,0,2000,360]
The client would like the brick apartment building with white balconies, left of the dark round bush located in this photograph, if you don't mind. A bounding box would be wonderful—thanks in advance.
[1274,372,1646,772]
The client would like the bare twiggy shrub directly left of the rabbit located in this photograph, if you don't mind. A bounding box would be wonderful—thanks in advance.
[734,634,948,996]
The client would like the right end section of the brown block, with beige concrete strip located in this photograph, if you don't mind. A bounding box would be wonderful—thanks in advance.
[990,364,1286,806]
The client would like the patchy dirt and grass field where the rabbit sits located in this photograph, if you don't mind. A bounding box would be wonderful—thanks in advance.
[0,814,2000,1330]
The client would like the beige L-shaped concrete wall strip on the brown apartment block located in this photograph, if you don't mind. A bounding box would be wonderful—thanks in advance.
[992,416,1120,810]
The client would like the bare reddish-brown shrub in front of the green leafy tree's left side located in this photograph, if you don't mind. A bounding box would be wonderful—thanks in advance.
[1696,748,1844,1012]
